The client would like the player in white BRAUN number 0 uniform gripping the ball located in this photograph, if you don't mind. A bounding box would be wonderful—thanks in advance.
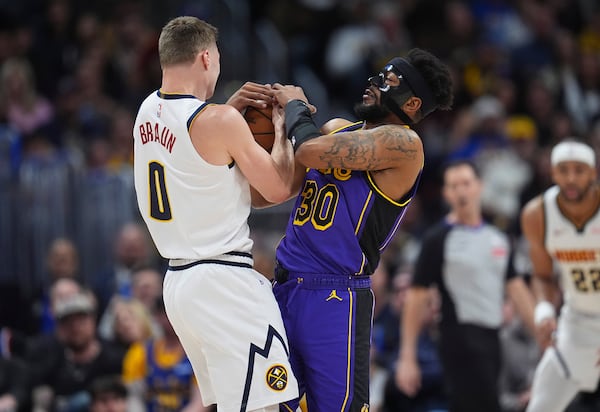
[133,16,298,412]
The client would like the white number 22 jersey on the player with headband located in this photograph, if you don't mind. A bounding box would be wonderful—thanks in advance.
[544,186,600,315]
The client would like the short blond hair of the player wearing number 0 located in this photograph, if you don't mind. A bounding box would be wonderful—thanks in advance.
[158,16,218,69]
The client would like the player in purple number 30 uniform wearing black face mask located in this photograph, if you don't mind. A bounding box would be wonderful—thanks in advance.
[273,49,452,412]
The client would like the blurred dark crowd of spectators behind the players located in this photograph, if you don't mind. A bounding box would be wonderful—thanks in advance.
[0,0,600,410]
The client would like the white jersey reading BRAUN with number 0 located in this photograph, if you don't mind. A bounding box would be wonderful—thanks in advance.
[133,91,252,259]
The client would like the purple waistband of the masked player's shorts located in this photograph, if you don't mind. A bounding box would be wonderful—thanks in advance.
[275,266,371,289]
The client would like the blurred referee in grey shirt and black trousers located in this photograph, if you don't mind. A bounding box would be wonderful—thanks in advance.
[396,160,534,412]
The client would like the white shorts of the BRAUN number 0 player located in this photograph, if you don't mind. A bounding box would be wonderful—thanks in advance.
[163,256,298,411]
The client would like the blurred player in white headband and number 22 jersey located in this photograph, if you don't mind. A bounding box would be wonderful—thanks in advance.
[521,140,600,412]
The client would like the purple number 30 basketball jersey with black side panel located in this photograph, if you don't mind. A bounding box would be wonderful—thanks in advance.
[277,123,420,275]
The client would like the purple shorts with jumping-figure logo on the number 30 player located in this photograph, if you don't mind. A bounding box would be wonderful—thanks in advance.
[273,273,373,412]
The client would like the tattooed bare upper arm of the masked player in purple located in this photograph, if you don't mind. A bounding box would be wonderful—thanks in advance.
[296,124,424,200]
